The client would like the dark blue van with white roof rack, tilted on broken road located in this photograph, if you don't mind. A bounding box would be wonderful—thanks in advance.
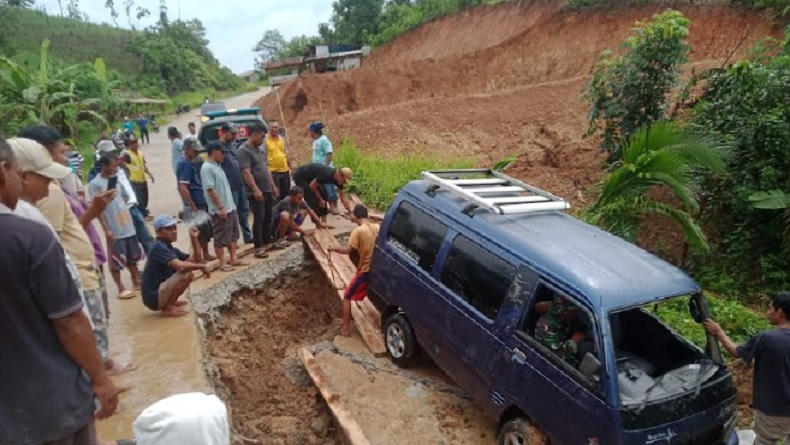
[368,170,738,445]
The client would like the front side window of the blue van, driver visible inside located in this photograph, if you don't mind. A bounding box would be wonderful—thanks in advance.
[518,283,598,387]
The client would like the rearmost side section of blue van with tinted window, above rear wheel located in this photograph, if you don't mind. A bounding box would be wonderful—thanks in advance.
[370,201,448,365]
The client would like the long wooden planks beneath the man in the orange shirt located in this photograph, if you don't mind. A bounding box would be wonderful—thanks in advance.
[304,229,387,357]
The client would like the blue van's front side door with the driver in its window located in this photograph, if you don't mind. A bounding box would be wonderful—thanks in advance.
[496,281,609,444]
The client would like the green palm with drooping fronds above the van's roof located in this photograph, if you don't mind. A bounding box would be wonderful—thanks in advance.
[583,121,729,251]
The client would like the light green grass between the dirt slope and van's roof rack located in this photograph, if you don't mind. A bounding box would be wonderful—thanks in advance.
[334,139,474,210]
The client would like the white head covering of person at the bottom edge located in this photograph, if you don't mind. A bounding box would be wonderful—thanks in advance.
[132,392,230,445]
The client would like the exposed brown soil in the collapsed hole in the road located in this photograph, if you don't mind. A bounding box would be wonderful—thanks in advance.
[206,262,345,445]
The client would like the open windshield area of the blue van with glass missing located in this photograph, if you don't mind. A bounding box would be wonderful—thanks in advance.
[609,296,720,406]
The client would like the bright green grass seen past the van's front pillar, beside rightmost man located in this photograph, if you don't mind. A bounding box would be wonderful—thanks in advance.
[654,294,771,347]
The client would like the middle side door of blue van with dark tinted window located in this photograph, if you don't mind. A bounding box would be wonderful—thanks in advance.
[438,234,516,409]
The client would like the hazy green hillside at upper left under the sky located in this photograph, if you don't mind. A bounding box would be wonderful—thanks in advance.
[9,9,142,76]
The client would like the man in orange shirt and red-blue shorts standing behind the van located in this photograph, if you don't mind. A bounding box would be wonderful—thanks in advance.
[329,204,379,337]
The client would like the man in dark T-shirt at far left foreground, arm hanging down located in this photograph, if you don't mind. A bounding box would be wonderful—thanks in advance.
[0,137,118,445]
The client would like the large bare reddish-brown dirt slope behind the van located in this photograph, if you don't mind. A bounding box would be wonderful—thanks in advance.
[259,3,778,203]
